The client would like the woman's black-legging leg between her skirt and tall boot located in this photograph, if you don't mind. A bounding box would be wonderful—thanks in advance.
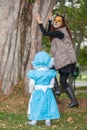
[60,73,69,89]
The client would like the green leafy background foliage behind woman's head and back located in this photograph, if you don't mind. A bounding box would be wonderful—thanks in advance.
[54,0,87,59]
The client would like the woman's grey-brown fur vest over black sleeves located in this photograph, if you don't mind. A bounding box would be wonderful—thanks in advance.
[51,27,76,69]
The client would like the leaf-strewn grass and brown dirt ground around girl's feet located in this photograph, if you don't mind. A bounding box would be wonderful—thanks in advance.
[0,89,87,130]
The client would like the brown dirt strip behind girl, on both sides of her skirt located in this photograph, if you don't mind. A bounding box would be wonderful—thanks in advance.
[0,90,87,113]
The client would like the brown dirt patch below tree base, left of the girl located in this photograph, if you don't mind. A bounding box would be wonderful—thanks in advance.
[0,93,29,113]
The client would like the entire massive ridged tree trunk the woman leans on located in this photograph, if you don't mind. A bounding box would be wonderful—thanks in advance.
[0,0,55,95]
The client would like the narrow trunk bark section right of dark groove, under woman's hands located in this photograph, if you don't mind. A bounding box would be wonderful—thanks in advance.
[24,0,55,92]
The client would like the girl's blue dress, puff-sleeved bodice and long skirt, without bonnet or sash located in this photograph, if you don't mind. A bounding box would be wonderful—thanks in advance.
[27,69,60,120]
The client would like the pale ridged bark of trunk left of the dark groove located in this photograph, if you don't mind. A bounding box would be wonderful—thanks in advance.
[0,0,23,94]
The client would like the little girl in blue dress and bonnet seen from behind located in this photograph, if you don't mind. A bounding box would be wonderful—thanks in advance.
[27,51,60,126]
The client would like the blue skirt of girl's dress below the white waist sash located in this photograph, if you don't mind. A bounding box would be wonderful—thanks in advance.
[28,88,60,120]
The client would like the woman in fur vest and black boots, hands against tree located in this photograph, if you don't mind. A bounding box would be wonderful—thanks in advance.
[36,14,78,108]
